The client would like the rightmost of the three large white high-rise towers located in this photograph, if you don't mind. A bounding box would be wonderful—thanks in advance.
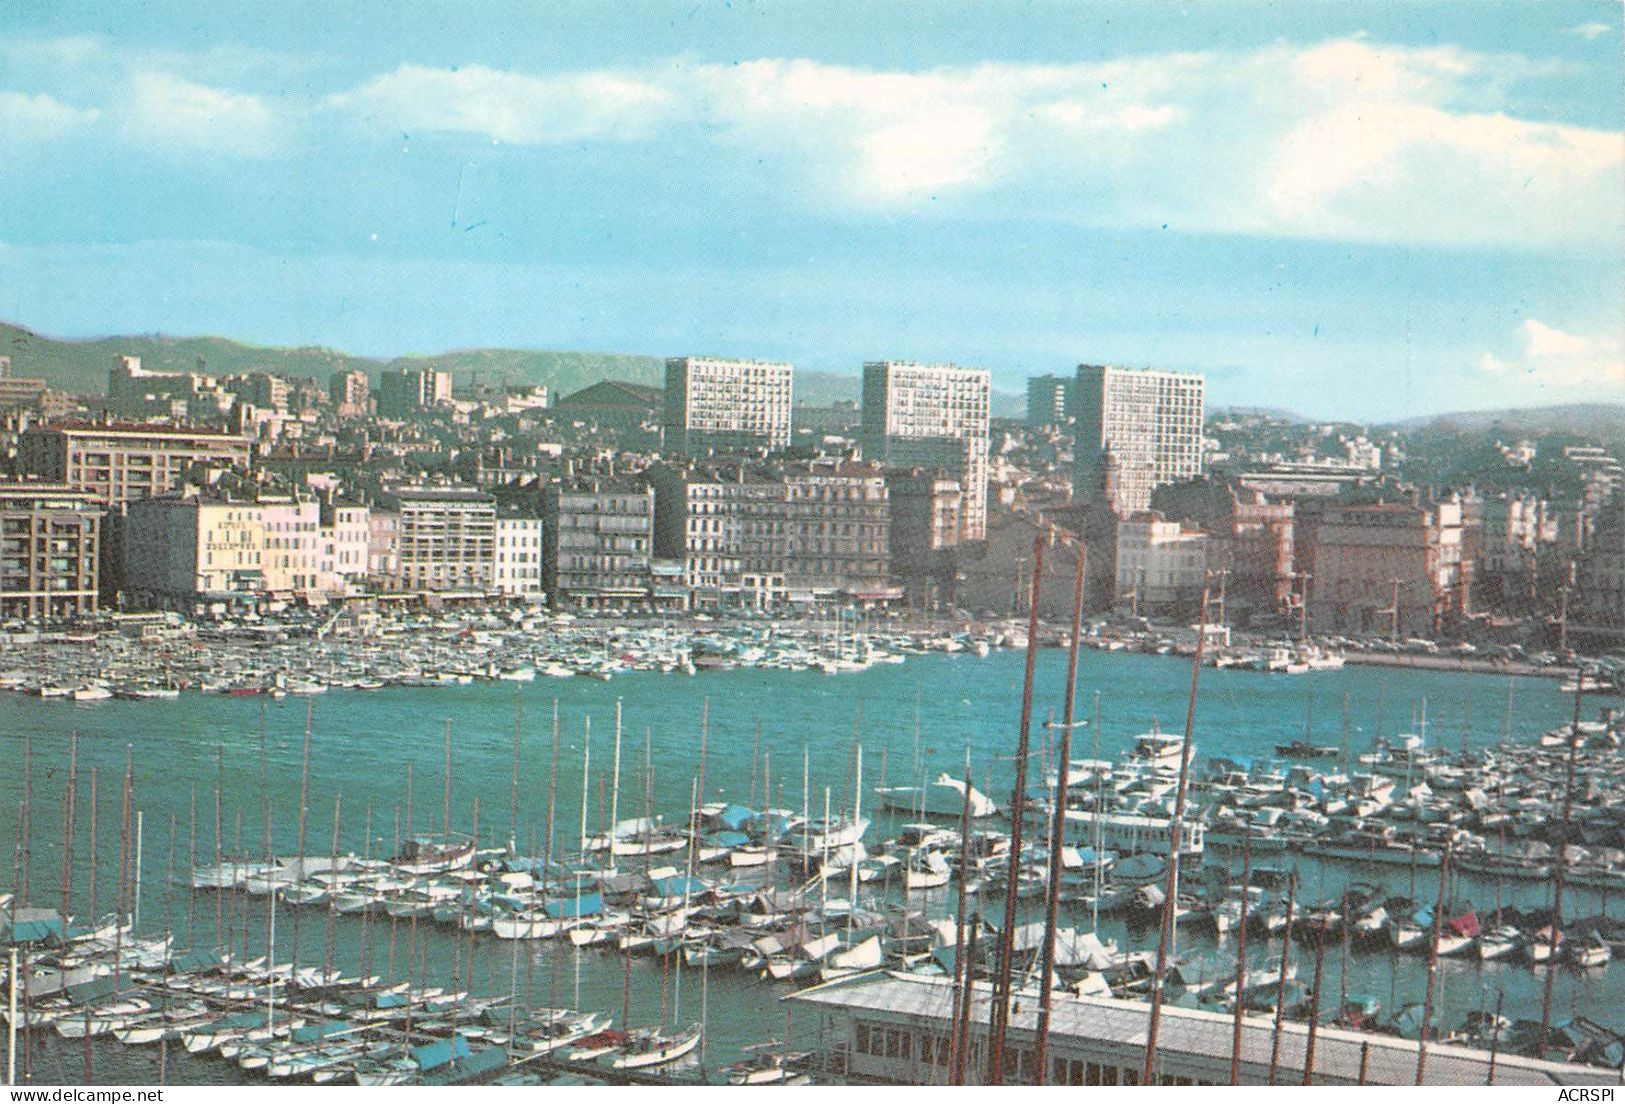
[1073,364,1204,514]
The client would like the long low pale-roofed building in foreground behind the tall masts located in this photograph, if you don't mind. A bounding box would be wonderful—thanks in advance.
[787,975,1619,1086]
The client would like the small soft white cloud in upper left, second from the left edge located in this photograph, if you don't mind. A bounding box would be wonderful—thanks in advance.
[120,73,289,158]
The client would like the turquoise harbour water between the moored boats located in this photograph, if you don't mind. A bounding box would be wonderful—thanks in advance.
[0,650,1625,1080]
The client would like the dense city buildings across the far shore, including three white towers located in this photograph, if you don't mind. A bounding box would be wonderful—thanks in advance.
[0,344,1625,666]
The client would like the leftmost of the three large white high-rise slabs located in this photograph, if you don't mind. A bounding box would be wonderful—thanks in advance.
[663,356,791,455]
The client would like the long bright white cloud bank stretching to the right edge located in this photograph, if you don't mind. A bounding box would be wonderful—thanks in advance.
[320,37,1622,249]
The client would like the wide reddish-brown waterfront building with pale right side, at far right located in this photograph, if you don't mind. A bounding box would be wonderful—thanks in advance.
[1308,499,1471,637]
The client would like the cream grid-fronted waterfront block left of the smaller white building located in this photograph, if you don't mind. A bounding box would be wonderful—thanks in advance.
[392,486,497,595]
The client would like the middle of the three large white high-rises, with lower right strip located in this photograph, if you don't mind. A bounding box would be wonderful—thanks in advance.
[861,361,993,541]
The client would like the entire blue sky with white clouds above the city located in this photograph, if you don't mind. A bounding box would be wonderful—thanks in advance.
[0,0,1625,419]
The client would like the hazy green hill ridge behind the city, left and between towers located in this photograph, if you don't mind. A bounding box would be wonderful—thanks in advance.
[0,322,1025,416]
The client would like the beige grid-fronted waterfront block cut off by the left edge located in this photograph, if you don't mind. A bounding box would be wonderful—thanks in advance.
[0,483,106,621]
